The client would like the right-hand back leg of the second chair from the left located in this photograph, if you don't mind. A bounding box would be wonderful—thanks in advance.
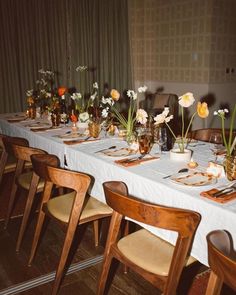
[16,173,39,252]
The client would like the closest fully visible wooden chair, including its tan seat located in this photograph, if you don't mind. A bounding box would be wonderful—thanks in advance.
[97,181,201,295]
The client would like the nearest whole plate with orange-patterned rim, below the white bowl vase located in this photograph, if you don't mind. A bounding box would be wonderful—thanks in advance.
[170,172,216,186]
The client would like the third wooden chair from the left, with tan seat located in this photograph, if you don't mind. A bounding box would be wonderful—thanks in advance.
[29,155,112,294]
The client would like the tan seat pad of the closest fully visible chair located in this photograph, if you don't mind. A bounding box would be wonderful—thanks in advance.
[117,229,196,276]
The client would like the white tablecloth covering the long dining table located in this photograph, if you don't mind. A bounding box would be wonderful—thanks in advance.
[0,114,236,265]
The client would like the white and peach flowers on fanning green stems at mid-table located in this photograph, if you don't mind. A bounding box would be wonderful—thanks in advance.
[102,86,148,136]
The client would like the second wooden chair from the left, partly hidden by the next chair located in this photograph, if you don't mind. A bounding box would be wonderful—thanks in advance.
[5,143,47,252]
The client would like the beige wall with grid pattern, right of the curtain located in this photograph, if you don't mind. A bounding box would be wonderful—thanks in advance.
[129,0,236,129]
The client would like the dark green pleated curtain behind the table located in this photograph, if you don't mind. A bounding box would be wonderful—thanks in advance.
[0,0,132,113]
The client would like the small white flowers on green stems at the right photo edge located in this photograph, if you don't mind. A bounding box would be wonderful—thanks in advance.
[214,105,236,156]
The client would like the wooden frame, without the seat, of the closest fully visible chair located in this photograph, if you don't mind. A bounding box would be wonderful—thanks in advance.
[97,181,201,295]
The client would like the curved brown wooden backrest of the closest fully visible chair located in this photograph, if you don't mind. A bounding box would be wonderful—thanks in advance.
[103,181,201,238]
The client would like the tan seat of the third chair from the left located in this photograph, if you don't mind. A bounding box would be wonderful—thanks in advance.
[47,192,112,223]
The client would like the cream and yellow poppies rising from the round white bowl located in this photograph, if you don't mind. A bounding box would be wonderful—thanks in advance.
[154,92,209,153]
